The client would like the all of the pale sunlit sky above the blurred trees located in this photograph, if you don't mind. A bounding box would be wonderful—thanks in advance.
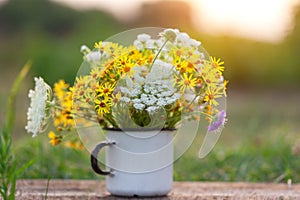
[0,0,300,42]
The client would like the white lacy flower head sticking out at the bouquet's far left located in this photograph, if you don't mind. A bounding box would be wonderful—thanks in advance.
[25,77,50,137]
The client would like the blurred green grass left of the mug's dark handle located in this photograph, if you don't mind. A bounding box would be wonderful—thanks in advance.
[16,136,97,179]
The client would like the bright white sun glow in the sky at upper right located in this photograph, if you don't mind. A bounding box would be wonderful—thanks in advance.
[191,0,298,42]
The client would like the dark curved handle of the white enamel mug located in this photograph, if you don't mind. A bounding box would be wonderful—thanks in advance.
[91,141,116,176]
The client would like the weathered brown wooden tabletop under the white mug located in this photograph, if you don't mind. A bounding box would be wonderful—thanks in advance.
[16,180,300,200]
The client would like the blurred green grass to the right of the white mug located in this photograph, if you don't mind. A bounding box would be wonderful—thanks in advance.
[175,136,300,182]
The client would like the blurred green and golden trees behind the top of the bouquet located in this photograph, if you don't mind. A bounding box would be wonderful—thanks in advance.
[0,0,300,88]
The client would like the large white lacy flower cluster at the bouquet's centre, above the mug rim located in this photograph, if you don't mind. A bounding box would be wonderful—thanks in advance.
[120,60,180,113]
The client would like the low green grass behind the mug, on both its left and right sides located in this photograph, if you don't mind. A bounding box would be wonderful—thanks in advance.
[16,123,300,182]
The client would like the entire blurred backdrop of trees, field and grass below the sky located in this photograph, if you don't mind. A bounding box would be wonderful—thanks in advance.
[0,0,300,182]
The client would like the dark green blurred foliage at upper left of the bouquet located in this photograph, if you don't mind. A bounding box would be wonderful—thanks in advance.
[0,0,122,83]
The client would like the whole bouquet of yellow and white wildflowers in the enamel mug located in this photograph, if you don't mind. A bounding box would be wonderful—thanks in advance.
[26,29,227,146]
